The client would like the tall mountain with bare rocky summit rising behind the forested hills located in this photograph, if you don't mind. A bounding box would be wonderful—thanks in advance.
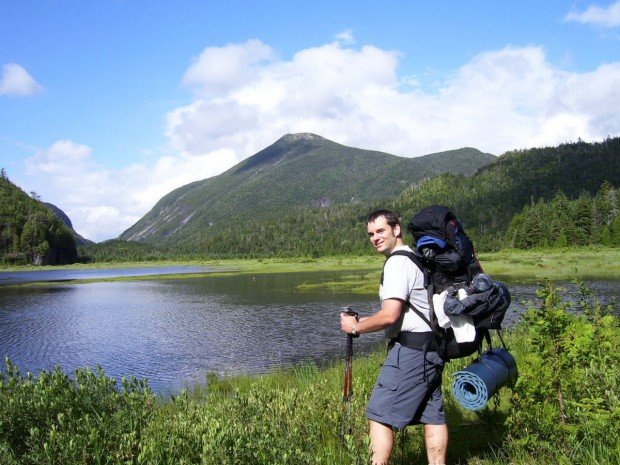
[120,133,496,243]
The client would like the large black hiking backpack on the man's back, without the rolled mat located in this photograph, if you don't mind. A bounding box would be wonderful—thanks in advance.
[388,205,510,360]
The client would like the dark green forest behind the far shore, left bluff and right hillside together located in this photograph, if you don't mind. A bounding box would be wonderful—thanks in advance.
[0,138,620,263]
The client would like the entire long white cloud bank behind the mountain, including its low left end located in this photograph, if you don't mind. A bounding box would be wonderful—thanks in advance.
[18,36,620,240]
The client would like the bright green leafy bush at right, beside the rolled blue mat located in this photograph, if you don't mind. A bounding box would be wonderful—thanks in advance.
[508,283,620,455]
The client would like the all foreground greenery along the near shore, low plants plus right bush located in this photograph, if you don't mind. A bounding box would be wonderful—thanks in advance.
[0,284,620,465]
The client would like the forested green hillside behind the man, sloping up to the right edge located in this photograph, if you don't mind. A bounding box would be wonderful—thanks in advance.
[77,138,620,260]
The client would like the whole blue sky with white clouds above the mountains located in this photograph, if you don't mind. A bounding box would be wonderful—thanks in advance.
[0,0,620,242]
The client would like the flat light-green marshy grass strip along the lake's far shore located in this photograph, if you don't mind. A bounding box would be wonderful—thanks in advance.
[0,247,620,293]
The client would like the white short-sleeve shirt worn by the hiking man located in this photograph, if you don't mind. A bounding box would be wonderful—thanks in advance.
[379,245,431,339]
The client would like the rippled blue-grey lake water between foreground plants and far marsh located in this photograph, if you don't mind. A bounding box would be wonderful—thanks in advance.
[0,270,620,395]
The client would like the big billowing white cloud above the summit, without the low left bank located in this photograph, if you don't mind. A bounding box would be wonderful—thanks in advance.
[167,36,620,158]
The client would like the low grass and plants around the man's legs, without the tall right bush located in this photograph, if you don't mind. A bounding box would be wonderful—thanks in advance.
[0,331,619,465]
